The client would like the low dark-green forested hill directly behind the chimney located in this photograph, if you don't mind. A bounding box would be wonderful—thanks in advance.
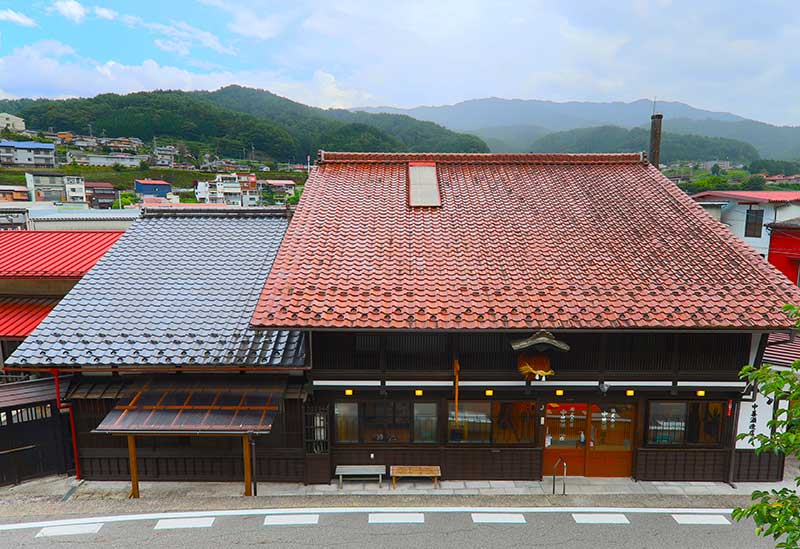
[529,126,759,164]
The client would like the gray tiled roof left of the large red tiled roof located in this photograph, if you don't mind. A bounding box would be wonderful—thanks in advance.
[7,209,305,368]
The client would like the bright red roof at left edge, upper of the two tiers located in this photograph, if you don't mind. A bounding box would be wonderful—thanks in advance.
[0,231,123,278]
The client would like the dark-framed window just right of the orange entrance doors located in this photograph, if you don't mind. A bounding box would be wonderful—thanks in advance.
[647,401,724,446]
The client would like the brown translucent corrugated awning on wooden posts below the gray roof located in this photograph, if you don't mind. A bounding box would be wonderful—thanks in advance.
[93,377,286,435]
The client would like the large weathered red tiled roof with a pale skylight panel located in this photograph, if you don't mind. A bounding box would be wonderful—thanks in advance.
[252,153,800,330]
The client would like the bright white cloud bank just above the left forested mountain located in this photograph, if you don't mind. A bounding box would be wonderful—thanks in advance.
[0,41,371,107]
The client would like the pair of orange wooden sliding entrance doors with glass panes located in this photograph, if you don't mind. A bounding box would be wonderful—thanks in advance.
[542,402,636,477]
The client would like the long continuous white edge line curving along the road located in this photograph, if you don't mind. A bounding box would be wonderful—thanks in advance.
[0,507,732,532]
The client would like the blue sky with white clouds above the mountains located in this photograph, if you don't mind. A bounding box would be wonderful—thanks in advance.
[0,0,800,125]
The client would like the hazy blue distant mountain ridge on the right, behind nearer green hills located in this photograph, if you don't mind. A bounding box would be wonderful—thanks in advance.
[354,98,800,159]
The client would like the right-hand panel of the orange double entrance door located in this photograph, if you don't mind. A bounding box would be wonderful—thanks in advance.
[586,403,636,477]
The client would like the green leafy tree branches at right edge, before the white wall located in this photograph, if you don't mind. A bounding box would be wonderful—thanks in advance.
[733,305,800,549]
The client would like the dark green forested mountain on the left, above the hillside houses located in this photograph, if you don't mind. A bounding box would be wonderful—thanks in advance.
[0,86,489,161]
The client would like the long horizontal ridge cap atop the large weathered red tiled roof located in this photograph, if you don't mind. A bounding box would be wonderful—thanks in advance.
[317,150,647,164]
